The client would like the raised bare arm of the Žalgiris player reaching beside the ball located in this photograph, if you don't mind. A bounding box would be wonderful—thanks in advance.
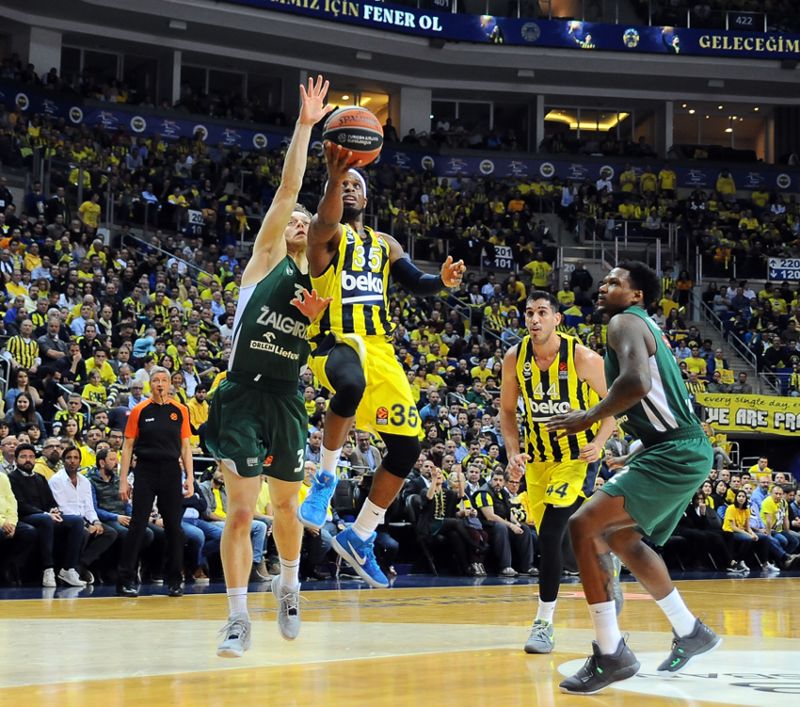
[253,76,334,255]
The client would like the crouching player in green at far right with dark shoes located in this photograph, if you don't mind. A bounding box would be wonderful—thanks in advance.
[546,261,720,695]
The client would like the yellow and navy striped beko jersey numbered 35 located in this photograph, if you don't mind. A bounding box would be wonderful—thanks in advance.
[309,224,393,338]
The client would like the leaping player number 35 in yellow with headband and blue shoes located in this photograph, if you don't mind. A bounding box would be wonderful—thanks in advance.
[298,142,465,587]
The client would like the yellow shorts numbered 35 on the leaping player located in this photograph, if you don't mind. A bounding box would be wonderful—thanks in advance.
[308,334,421,437]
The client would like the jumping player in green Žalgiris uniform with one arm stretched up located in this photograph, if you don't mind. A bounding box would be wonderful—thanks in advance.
[206,76,333,658]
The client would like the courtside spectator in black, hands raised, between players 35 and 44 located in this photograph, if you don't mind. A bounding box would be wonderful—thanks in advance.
[416,468,478,575]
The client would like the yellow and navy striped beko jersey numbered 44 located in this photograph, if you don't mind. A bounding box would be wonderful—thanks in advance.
[517,333,600,462]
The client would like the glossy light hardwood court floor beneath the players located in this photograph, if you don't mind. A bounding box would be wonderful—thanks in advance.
[0,578,800,707]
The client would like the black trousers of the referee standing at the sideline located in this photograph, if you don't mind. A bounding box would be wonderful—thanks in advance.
[119,459,183,586]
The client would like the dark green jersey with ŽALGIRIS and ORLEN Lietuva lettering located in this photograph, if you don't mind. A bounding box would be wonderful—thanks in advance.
[228,255,311,385]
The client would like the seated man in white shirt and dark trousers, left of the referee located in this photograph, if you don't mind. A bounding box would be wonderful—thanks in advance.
[48,447,117,584]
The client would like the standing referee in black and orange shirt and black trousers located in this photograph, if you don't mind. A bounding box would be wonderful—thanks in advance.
[117,366,194,597]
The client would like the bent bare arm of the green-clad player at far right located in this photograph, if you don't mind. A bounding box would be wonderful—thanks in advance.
[545,313,653,436]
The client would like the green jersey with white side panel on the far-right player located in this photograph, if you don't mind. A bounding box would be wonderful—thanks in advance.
[605,307,704,446]
